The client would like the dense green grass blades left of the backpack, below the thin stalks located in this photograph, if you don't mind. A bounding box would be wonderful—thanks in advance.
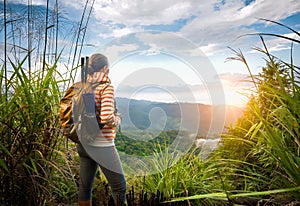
[0,55,76,205]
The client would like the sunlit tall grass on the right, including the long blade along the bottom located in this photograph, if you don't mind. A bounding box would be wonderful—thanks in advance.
[152,21,300,205]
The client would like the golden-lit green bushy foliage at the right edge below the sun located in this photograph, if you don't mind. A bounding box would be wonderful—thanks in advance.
[220,21,300,200]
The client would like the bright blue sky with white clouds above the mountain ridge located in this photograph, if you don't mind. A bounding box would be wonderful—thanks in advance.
[1,0,300,106]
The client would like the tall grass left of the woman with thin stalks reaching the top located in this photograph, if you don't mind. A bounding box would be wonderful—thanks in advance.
[0,0,103,205]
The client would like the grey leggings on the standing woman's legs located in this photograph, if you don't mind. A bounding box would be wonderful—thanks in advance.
[77,144,126,206]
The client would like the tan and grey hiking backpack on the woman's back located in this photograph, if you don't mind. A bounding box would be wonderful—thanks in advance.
[59,82,104,143]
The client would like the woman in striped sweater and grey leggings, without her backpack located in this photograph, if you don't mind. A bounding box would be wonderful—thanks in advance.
[77,54,126,206]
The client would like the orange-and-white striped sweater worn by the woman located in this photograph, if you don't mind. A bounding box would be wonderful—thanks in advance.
[87,72,120,147]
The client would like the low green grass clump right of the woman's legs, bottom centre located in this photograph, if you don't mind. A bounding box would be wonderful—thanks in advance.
[129,146,230,205]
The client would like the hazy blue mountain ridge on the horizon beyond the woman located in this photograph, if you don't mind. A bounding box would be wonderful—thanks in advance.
[116,98,243,136]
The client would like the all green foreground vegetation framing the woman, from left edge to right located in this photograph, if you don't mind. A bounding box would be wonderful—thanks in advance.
[0,1,300,205]
